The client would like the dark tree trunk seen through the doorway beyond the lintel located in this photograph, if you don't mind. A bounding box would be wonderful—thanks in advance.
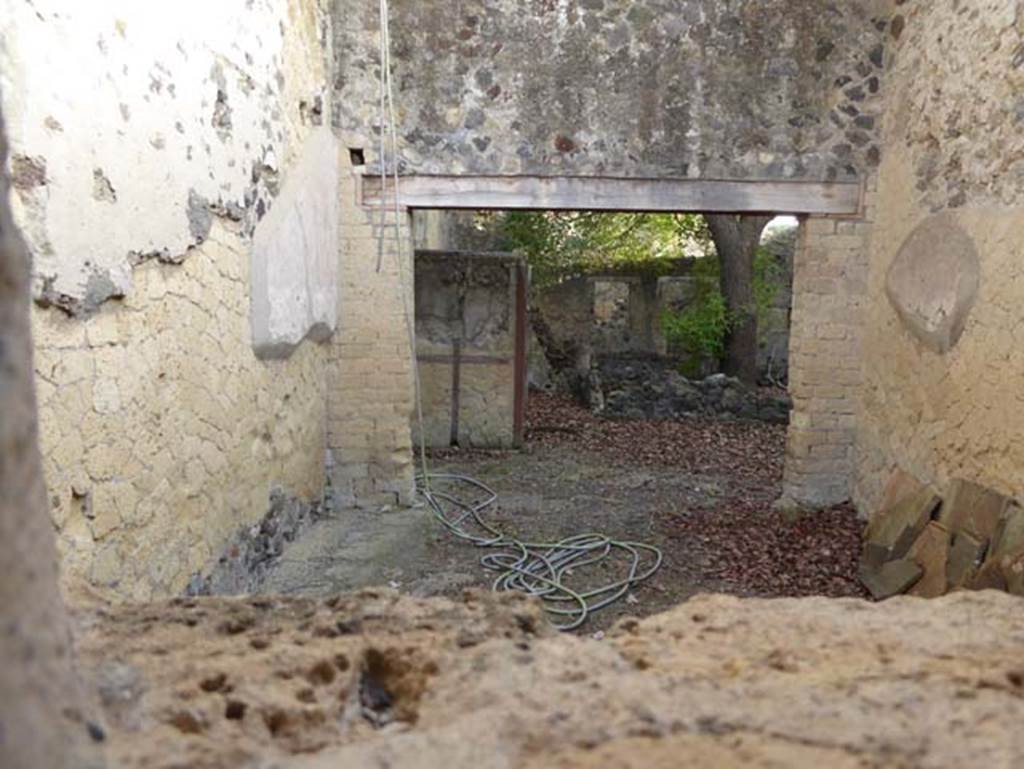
[707,214,771,386]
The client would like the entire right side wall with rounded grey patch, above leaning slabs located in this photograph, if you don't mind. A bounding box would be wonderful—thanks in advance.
[855,2,1024,512]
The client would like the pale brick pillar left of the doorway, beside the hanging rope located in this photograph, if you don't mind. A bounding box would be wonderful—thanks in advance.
[328,152,414,507]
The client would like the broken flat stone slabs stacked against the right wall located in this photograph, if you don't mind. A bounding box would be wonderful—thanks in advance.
[860,471,1024,599]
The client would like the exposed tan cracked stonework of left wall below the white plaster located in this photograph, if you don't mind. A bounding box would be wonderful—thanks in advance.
[34,221,327,599]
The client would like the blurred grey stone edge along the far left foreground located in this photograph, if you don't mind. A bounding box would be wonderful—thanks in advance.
[0,103,100,769]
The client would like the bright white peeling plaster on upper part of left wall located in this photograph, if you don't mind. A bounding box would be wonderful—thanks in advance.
[0,0,330,313]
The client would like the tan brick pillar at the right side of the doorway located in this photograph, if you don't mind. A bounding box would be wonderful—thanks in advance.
[778,180,876,509]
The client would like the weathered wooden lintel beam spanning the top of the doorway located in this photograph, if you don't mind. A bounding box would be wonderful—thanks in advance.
[360,176,861,215]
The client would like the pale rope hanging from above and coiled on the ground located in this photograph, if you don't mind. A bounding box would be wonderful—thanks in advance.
[377,0,663,630]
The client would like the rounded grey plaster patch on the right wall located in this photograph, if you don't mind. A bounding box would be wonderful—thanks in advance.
[886,213,981,353]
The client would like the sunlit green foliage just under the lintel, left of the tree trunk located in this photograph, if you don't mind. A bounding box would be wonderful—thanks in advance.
[497,212,711,286]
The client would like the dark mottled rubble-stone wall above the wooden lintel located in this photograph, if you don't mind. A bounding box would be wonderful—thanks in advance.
[334,0,890,180]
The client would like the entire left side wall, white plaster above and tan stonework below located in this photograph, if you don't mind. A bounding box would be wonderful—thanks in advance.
[0,0,338,598]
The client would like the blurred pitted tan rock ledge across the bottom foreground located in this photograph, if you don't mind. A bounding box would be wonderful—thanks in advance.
[77,591,1024,769]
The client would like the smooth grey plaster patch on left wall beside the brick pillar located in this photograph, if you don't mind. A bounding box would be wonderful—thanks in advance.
[252,128,339,357]
